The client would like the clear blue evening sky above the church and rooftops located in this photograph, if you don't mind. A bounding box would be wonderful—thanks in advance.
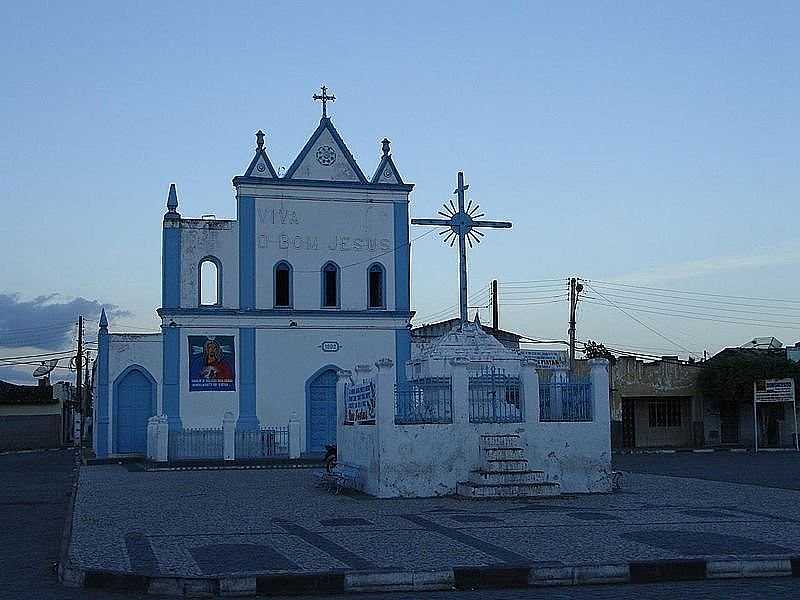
[0,0,800,383]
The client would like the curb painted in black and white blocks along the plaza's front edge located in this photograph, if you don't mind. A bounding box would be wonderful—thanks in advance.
[59,556,800,597]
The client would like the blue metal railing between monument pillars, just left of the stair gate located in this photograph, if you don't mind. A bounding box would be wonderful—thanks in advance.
[394,377,453,425]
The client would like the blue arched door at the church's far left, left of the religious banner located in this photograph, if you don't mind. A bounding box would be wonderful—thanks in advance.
[116,369,155,454]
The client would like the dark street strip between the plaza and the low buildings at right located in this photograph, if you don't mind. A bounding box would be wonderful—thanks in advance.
[614,451,800,490]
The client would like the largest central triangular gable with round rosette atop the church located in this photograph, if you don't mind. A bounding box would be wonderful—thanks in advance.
[284,117,367,183]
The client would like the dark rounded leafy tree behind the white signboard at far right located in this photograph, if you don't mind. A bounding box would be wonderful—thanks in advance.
[697,348,800,402]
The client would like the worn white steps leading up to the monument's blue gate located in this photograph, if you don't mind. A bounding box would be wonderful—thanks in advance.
[456,433,561,498]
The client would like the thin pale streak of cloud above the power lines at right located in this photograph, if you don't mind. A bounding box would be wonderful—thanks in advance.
[611,245,800,285]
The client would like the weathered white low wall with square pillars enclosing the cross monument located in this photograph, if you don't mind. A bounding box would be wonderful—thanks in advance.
[338,361,611,497]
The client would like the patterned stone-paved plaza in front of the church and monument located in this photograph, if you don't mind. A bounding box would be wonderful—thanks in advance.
[71,465,800,577]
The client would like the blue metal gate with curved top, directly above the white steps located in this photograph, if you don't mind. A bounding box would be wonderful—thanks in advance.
[469,367,523,423]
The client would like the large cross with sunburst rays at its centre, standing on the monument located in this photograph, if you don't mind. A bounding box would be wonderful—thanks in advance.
[411,171,511,322]
